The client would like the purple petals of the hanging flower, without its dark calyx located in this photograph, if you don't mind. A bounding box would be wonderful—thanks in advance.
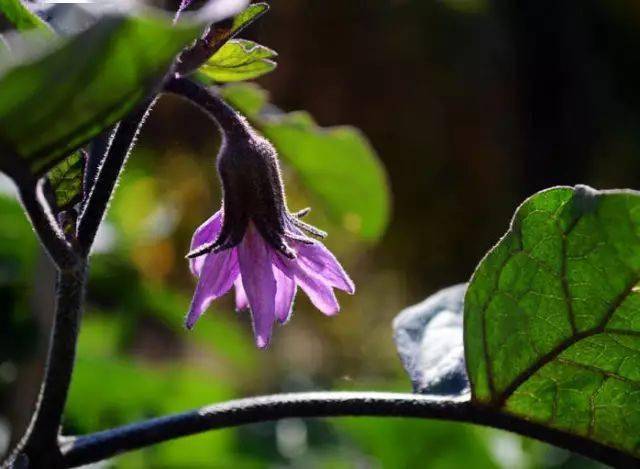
[186,210,355,348]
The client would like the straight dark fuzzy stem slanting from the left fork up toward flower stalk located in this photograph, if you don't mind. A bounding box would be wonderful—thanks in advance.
[77,97,155,255]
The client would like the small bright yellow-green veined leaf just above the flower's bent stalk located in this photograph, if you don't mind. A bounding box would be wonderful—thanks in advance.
[198,39,277,84]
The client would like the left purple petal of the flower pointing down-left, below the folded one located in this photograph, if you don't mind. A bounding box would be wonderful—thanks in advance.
[186,249,240,329]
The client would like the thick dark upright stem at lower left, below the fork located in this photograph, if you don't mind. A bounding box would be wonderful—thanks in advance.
[12,262,86,468]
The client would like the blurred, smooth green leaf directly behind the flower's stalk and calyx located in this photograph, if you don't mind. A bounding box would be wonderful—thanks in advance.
[222,84,390,240]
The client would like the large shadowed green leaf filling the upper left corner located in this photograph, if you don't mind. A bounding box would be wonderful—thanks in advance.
[0,16,200,174]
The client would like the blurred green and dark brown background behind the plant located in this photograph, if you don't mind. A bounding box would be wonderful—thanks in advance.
[0,0,640,468]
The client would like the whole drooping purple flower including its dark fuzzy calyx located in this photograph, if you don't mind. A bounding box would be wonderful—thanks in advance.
[186,84,355,348]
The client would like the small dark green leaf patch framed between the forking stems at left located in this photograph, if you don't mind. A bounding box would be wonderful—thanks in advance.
[47,150,86,210]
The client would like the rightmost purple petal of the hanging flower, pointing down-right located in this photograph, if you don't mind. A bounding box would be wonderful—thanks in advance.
[296,241,356,294]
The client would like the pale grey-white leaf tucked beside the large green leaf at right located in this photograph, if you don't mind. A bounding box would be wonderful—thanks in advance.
[393,284,469,395]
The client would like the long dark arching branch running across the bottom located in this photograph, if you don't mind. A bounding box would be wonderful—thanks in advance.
[62,392,638,467]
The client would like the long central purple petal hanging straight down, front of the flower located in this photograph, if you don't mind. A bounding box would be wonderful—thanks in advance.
[238,223,276,348]
